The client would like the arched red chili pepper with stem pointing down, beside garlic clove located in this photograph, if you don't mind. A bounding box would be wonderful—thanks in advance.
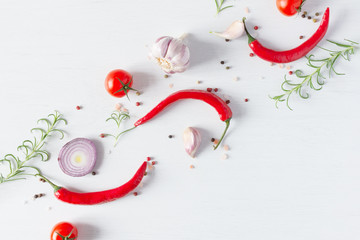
[134,89,232,150]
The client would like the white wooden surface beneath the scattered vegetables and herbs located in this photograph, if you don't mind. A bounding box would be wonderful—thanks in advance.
[0,0,360,240]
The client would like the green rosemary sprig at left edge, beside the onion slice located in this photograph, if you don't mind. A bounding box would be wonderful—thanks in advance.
[0,111,67,183]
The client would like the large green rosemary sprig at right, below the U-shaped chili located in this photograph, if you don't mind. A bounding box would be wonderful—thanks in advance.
[270,39,359,110]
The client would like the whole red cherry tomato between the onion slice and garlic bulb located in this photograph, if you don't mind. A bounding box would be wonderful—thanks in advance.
[105,69,136,98]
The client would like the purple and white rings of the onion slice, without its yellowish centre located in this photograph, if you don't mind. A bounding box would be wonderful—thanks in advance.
[58,138,97,177]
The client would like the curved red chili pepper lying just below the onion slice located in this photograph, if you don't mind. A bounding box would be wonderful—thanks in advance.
[38,162,147,205]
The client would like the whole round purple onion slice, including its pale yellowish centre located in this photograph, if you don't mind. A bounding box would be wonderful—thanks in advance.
[58,138,96,177]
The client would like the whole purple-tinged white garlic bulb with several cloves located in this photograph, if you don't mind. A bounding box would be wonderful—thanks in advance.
[150,36,190,74]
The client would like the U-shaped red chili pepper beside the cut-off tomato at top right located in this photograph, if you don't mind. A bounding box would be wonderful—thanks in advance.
[243,8,330,63]
